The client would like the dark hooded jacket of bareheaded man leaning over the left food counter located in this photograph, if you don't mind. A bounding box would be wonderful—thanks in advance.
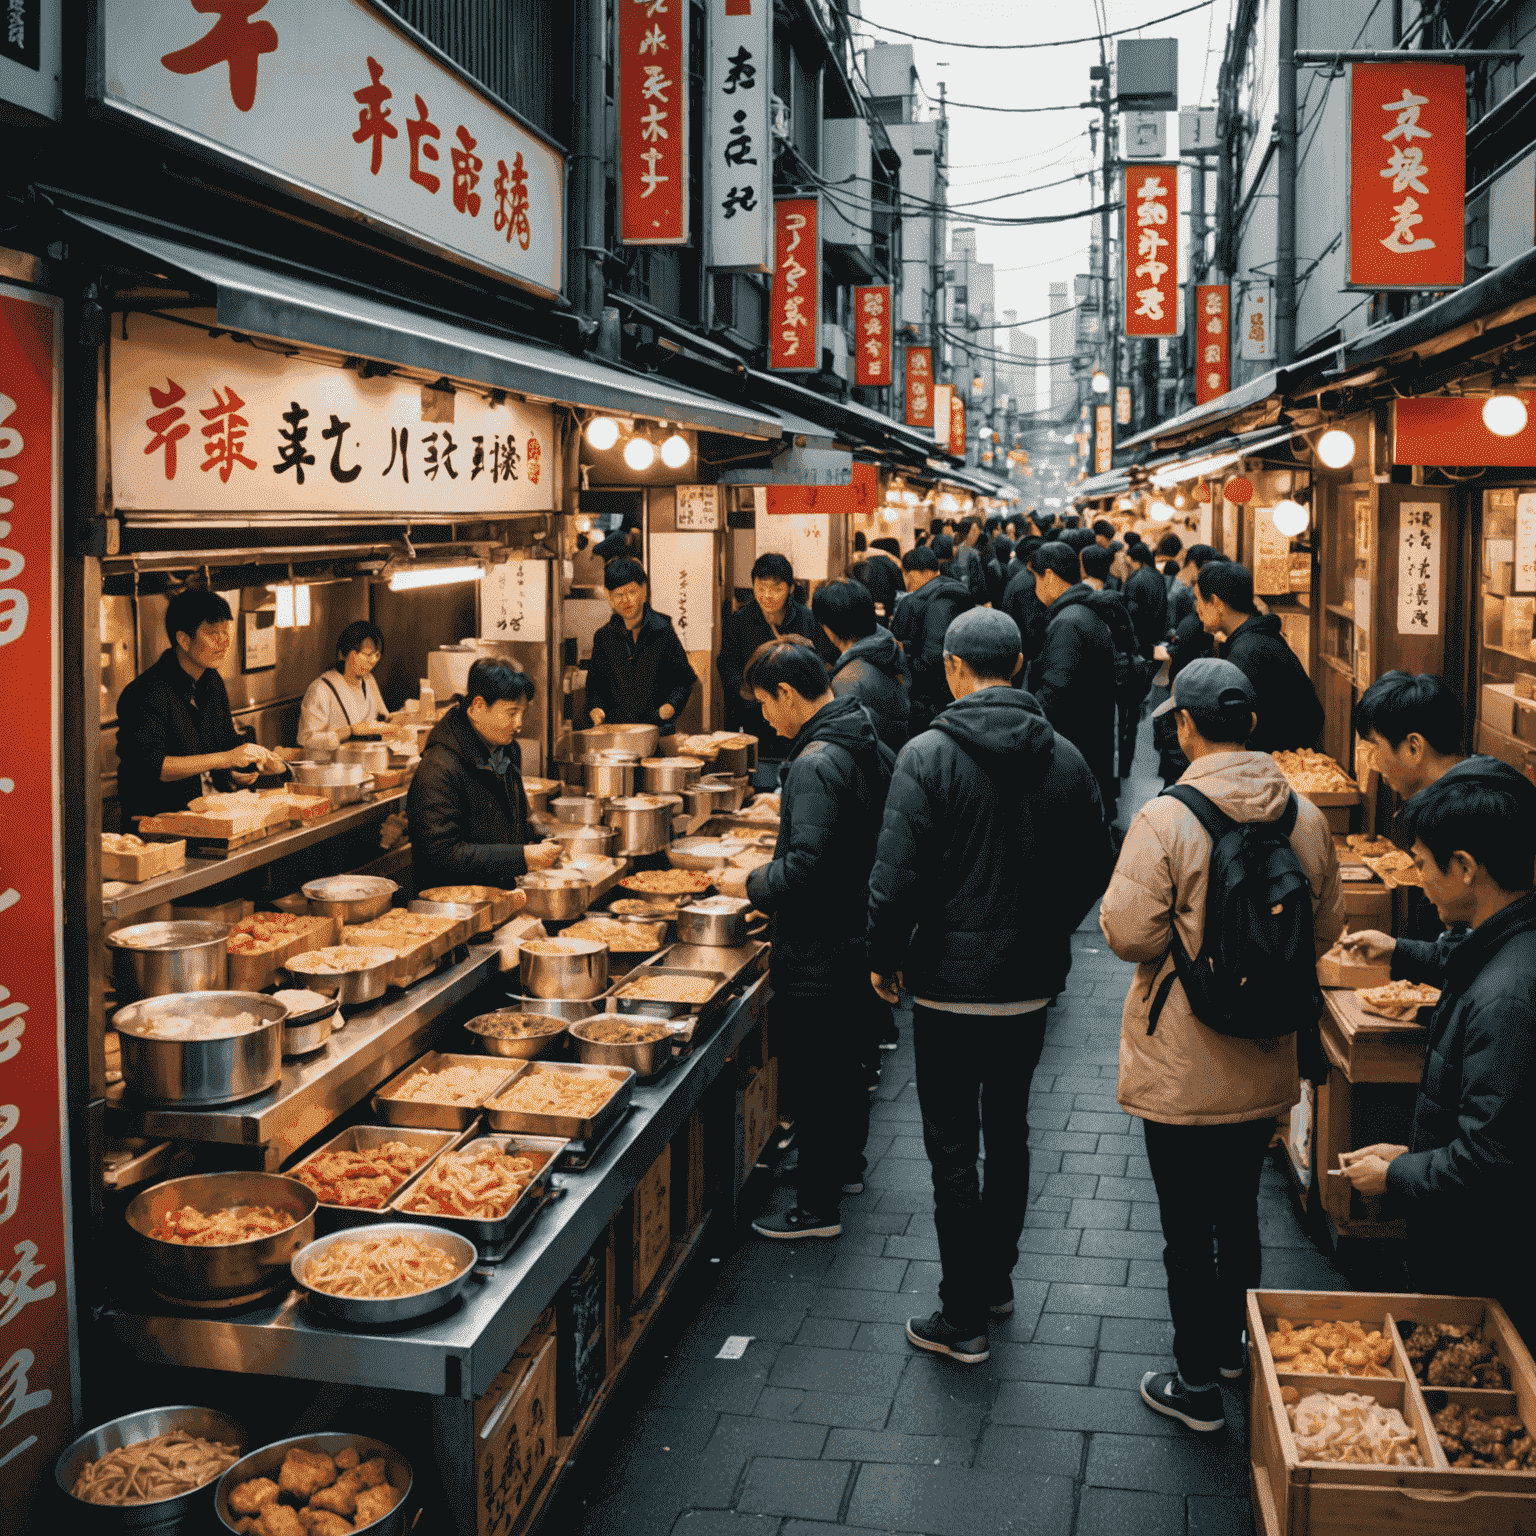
[746,697,895,998]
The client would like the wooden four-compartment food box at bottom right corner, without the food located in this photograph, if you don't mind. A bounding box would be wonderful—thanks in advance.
[1247,1290,1536,1536]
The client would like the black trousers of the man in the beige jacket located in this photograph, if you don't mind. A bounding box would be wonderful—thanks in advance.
[1141,1118,1275,1387]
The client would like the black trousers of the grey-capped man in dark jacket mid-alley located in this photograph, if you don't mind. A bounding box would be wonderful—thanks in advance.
[912,1003,1046,1333]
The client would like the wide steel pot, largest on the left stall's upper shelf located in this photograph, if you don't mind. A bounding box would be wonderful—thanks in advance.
[112,992,287,1107]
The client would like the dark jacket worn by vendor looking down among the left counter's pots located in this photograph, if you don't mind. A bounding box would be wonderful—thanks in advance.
[406,703,538,891]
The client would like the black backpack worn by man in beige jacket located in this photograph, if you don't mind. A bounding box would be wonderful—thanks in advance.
[1147,783,1322,1040]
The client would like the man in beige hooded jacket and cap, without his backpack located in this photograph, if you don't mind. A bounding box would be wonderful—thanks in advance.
[1098,657,1344,1433]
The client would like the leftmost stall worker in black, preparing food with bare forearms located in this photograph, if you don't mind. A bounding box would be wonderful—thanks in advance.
[117,587,283,831]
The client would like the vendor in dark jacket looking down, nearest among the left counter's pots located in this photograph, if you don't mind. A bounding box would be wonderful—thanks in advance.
[406,657,561,891]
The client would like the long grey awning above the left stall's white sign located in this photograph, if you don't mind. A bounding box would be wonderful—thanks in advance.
[69,212,780,439]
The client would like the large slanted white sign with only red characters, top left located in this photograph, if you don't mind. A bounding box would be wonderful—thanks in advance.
[97,0,565,295]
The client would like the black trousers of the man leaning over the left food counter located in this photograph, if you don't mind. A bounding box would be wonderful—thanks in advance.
[768,968,869,1217]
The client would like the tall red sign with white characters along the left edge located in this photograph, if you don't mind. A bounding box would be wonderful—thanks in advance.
[0,284,78,1531]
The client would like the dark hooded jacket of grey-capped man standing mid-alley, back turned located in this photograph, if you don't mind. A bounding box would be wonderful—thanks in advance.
[868,688,1114,1003]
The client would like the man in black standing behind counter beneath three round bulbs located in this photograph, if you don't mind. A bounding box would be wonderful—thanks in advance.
[587,556,697,725]
